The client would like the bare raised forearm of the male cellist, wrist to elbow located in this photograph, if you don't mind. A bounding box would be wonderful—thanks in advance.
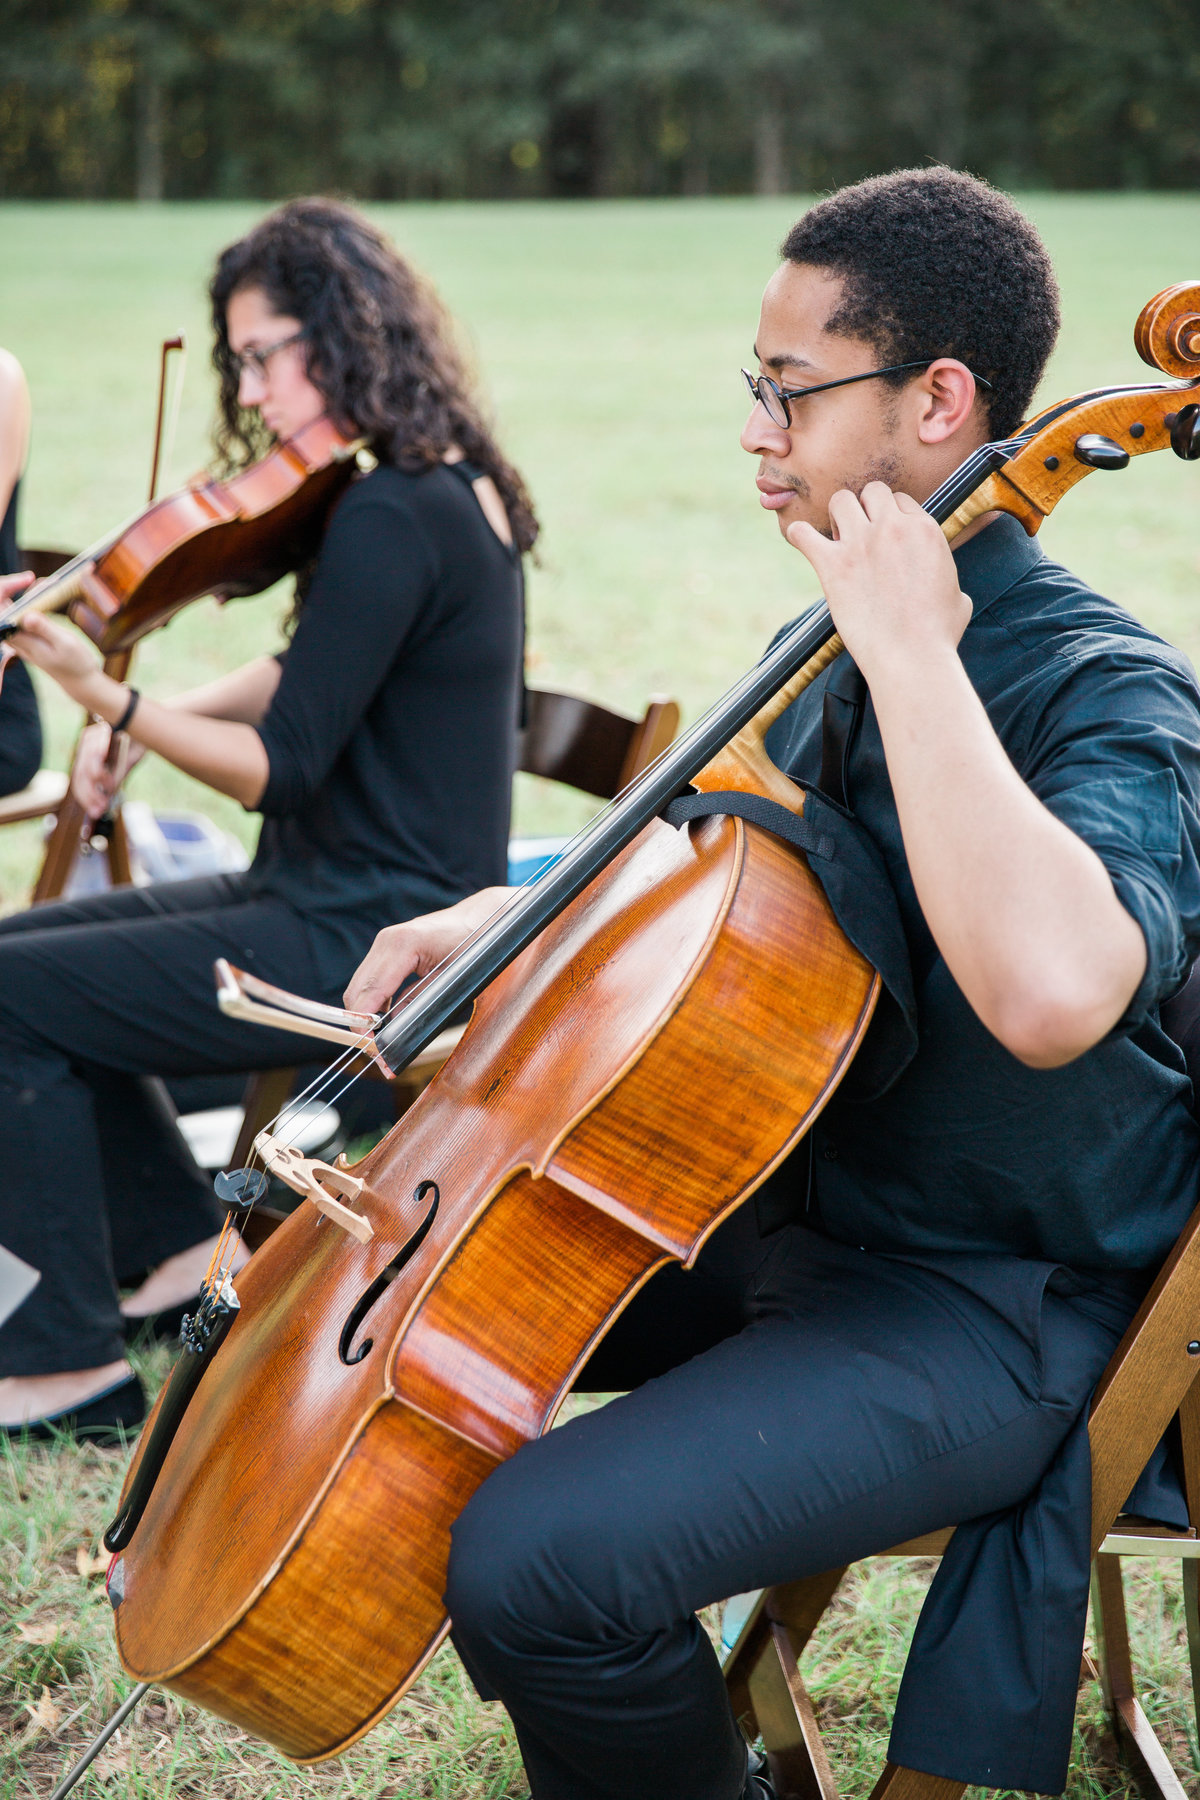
[871,646,1146,1067]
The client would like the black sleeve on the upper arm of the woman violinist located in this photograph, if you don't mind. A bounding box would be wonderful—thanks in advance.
[254,479,437,817]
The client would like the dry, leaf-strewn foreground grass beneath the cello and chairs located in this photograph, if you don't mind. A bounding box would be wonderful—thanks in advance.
[0,1352,1200,1800]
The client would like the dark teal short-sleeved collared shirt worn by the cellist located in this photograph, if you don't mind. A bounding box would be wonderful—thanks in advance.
[768,518,1200,1273]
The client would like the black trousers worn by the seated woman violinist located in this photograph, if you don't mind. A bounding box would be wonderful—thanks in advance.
[0,875,356,1375]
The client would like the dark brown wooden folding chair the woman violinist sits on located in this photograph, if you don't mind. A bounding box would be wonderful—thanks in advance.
[230,688,680,1242]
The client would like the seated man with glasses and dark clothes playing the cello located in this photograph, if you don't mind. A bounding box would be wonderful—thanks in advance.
[354,169,1200,1800]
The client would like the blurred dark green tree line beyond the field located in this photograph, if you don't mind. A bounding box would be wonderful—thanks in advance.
[0,0,1200,200]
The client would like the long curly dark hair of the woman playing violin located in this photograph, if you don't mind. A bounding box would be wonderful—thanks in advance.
[209,196,538,551]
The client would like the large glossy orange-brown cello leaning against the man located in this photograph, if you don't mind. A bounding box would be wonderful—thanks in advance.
[59,283,1200,1771]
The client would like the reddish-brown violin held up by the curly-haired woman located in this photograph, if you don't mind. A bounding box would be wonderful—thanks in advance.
[0,416,363,657]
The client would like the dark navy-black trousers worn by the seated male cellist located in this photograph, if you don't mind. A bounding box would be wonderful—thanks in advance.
[446,1208,1132,1800]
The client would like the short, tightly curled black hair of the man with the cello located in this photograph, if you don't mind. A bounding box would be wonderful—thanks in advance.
[779,167,1058,437]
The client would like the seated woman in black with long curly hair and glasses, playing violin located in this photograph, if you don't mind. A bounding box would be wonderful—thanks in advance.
[0,200,538,1433]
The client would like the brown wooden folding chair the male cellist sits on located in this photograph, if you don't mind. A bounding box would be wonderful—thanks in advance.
[725,1208,1200,1800]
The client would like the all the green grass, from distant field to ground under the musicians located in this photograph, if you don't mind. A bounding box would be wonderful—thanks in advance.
[0,196,1200,1800]
